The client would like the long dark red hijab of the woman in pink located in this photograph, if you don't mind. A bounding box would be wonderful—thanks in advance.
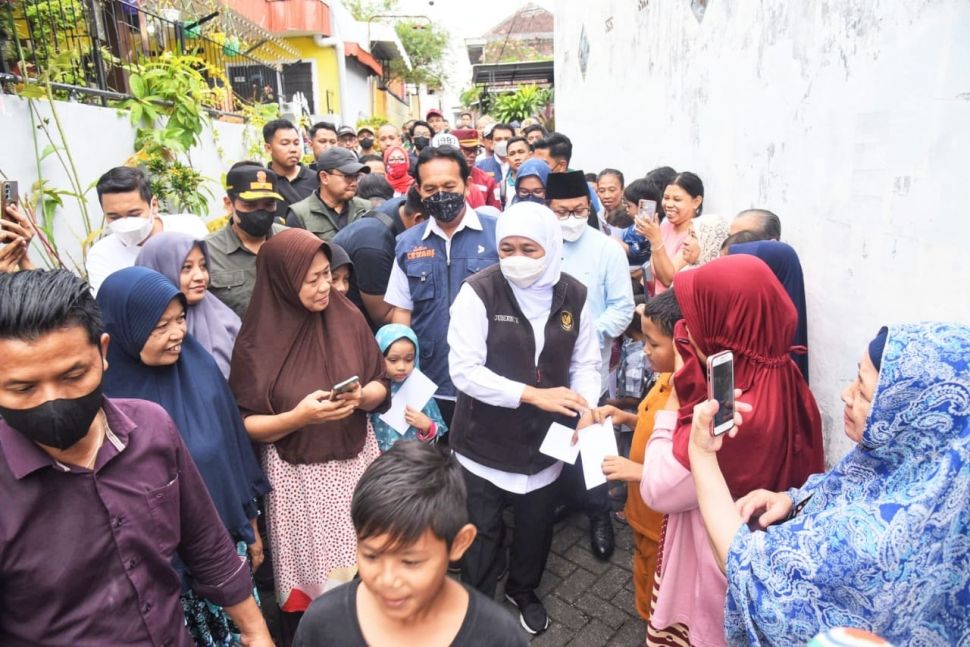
[674,255,825,498]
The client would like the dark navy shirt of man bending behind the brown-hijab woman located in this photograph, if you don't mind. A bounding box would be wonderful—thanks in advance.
[333,216,394,332]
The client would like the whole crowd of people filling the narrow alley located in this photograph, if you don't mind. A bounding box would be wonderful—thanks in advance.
[0,110,970,646]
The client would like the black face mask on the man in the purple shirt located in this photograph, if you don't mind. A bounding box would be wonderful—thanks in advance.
[0,382,102,451]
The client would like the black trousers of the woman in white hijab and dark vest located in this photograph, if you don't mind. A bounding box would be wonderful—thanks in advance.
[461,467,558,598]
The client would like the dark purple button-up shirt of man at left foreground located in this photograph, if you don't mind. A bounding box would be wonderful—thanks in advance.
[0,399,252,647]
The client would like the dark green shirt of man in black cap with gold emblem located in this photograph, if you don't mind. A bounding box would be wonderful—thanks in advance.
[205,222,286,319]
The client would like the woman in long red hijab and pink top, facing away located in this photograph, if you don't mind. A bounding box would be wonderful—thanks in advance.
[640,255,824,645]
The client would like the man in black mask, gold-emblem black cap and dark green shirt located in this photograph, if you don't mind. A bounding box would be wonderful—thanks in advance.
[205,162,286,319]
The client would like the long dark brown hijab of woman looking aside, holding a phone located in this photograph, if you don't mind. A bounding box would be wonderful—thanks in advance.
[229,229,387,464]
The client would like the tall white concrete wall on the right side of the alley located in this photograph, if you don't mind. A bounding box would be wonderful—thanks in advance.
[555,0,970,463]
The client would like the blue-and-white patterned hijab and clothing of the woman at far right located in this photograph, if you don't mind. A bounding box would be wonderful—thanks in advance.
[724,323,970,645]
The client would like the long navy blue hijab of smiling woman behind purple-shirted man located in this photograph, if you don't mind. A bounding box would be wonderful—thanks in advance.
[98,267,269,543]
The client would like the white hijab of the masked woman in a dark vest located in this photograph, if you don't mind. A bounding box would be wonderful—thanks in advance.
[495,202,562,319]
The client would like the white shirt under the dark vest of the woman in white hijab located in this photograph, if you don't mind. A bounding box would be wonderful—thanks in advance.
[448,285,600,494]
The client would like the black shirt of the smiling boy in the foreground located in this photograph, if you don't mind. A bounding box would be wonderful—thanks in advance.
[293,580,529,647]
